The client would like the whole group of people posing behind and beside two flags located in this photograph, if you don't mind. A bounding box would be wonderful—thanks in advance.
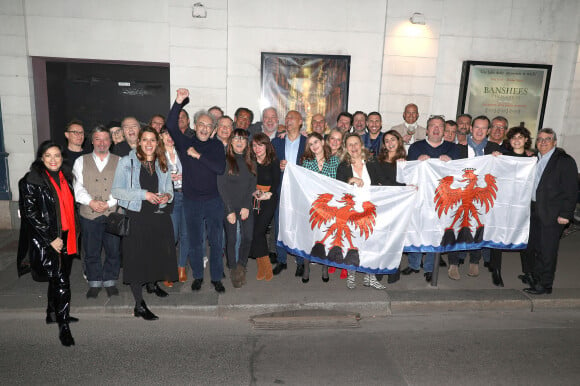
[18,89,577,346]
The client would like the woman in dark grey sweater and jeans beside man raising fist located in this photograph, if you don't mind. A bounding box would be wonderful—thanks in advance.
[217,129,256,288]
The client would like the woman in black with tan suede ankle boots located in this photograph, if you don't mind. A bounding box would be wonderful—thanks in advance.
[250,133,280,281]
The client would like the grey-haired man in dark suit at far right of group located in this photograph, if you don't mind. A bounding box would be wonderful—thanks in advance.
[519,128,578,295]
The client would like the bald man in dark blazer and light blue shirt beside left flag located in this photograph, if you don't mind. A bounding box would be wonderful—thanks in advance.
[272,110,306,277]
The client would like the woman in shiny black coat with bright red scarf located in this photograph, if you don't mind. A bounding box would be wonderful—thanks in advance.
[18,141,79,346]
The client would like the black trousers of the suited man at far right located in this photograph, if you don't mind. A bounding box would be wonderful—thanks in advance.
[522,205,564,288]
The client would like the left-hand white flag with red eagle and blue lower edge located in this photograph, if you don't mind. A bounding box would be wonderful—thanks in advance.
[278,164,417,273]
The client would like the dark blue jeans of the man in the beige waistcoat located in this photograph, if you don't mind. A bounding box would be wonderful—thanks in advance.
[80,216,121,287]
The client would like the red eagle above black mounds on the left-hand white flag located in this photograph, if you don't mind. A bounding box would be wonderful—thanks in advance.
[309,193,377,266]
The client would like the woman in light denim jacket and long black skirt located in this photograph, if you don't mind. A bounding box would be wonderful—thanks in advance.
[112,126,178,320]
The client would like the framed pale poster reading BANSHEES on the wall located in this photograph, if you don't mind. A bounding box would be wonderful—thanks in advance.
[457,61,552,136]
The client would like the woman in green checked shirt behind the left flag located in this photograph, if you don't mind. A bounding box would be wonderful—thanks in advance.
[301,132,340,283]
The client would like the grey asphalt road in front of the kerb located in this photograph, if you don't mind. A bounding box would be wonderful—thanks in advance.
[0,310,580,385]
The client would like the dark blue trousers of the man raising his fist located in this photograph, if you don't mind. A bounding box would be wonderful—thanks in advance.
[183,197,224,281]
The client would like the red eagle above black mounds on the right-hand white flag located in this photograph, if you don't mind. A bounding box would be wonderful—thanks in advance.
[433,168,497,245]
